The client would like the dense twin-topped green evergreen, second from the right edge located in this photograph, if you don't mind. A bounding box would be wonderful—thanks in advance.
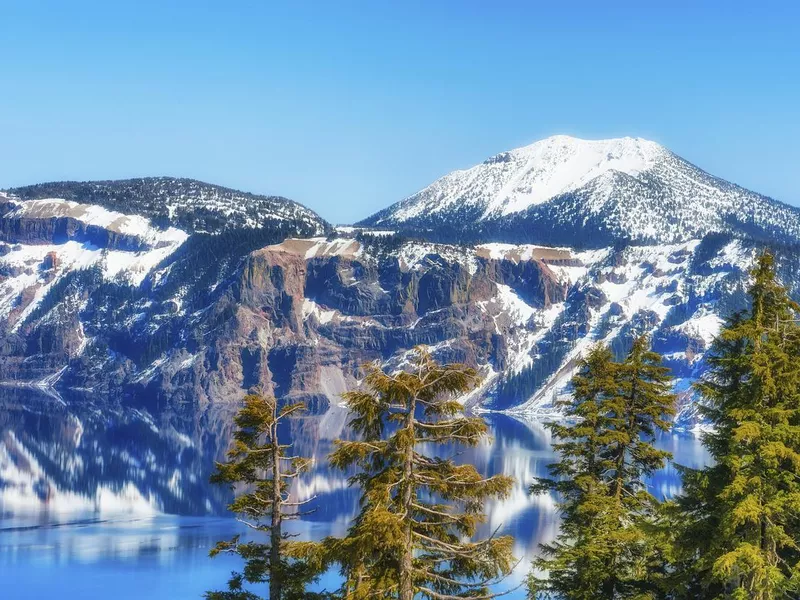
[528,337,675,600]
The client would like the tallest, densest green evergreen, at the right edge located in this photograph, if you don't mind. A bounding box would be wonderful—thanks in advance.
[676,253,800,600]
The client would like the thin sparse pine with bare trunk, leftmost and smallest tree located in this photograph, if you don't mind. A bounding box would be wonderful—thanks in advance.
[206,395,324,600]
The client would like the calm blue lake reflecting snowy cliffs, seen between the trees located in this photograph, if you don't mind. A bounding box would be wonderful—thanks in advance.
[0,388,708,600]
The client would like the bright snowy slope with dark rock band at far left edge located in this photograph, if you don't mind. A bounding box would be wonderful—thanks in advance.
[0,195,189,387]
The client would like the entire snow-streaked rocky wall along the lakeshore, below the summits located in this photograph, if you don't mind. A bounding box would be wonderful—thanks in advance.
[0,190,800,422]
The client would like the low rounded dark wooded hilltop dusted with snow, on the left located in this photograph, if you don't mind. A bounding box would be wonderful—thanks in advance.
[9,177,330,235]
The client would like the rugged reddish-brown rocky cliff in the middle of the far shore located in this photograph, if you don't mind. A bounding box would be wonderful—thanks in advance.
[112,239,568,409]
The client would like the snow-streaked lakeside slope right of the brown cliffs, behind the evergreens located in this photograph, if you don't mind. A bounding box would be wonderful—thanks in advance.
[489,236,800,427]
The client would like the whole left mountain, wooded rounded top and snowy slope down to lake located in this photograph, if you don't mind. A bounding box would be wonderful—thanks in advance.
[0,179,329,389]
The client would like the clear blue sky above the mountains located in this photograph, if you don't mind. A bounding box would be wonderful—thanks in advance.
[0,0,800,223]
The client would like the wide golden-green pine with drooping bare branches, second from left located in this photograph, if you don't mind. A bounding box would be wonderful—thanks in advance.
[328,348,513,600]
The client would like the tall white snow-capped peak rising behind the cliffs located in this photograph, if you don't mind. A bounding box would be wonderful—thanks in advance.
[362,136,800,247]
